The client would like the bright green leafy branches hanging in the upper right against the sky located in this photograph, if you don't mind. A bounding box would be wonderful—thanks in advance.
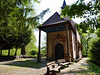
[62,0,100,33]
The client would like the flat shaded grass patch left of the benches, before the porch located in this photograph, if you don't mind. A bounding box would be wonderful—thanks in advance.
[4,60,45,68]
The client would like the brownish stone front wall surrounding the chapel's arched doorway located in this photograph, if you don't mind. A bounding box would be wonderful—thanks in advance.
[48,31,67,60]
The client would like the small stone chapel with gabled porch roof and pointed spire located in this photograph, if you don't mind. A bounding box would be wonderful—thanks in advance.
[38,0,82,62]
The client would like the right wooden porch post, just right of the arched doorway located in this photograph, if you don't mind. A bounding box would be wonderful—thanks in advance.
[65,24,71,62]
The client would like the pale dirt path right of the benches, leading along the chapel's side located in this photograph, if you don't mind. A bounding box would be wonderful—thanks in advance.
[57,58,89,75]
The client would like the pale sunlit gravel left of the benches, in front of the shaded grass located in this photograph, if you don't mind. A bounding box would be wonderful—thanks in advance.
[0,67,46,75]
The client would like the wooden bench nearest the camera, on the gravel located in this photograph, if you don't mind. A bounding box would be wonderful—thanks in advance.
[47,61,61,75]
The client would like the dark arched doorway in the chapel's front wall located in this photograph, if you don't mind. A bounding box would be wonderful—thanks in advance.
[55,43,64,59]
